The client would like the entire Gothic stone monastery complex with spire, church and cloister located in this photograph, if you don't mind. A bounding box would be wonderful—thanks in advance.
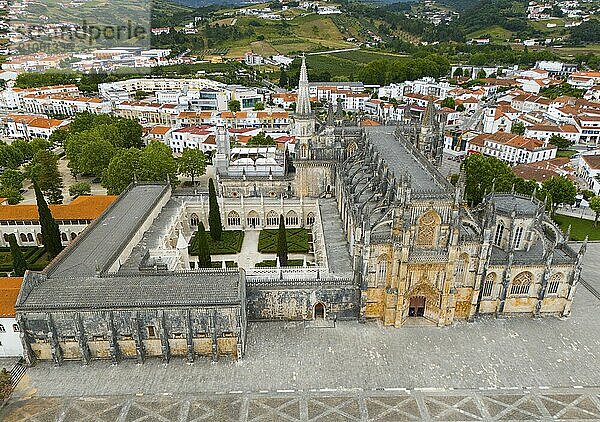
[15,57,585,364]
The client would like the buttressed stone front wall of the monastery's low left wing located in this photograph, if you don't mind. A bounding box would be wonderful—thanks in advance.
[20,306,246,364]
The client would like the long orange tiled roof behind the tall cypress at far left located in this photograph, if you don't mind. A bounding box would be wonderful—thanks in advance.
[0,196,117,221]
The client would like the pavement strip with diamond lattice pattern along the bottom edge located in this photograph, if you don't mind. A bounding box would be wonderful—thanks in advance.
[3,388,600,422]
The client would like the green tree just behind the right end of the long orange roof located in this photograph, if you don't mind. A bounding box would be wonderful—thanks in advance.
[102,148,142,195]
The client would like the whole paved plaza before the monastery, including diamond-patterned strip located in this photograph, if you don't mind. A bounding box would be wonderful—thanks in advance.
[0,244,600,421]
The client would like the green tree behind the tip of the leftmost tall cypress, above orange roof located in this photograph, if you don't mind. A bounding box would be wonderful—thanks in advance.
[27,150,63,204]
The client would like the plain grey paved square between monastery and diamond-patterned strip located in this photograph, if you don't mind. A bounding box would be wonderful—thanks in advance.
[7,244,600,400]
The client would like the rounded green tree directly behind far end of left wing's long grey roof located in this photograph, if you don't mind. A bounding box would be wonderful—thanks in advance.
[138,141,178,186]
